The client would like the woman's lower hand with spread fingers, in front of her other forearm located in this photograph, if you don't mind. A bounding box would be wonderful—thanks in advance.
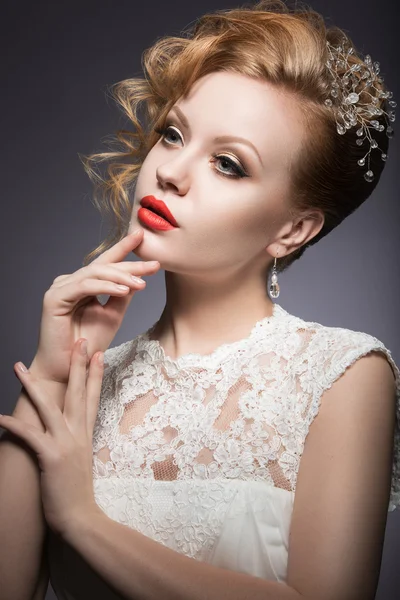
[0,340,104,535]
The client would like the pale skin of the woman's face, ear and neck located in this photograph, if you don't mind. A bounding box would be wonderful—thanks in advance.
[130,72,324,358]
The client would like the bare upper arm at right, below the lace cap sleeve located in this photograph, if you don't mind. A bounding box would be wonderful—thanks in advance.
[287,351,396,600]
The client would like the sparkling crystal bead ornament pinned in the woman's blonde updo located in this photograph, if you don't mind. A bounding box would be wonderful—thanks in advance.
[325,38,397,182]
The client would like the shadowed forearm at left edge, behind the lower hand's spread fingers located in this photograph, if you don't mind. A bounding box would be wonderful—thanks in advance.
[0,382,65,600]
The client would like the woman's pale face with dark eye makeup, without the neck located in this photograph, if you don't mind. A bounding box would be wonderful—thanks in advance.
[129,72,303,281]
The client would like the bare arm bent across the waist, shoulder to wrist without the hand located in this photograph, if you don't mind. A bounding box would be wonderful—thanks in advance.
[64,355,395,600]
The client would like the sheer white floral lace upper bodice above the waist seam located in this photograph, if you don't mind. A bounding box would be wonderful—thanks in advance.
[94,304,400,510]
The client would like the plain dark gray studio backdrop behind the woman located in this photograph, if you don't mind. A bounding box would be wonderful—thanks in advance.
[0,0,400,600]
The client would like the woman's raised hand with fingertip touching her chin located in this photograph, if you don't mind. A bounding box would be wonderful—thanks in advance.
[30,229,160,384]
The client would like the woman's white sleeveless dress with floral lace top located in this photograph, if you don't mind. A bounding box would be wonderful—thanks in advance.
[47,304,400,600]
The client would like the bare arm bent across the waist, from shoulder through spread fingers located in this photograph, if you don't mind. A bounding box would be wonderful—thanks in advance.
[0,343,395,600]
